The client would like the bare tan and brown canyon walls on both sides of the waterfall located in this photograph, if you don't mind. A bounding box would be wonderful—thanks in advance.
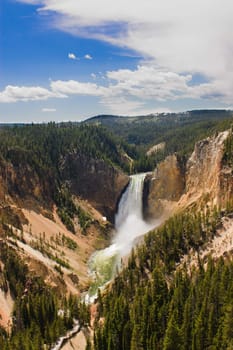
[0,121,233,349]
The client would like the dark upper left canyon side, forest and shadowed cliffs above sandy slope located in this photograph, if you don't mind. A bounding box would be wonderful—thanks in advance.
[0,124,127,214]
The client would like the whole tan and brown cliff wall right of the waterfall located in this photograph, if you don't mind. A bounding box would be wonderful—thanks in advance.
[144,131,233,218]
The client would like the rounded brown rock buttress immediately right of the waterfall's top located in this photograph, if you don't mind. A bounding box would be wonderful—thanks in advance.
[143,155,185,218]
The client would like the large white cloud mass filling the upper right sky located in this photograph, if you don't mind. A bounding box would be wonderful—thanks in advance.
[14,0,233,112]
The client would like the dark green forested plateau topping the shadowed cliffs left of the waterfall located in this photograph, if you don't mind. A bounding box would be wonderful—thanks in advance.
[0,123,128,175]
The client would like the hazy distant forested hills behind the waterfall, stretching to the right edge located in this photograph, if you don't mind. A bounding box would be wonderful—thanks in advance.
[84,110,233,172]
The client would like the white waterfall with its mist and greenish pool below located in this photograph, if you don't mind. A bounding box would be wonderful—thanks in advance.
[88,174,156,300]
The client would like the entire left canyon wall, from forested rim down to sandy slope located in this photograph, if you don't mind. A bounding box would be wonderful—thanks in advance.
[0,124,128,336]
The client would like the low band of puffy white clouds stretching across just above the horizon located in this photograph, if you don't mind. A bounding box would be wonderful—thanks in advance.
[0,65,233,114]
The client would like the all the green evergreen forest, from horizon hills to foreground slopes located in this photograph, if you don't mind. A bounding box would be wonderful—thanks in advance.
[0,111,233,350]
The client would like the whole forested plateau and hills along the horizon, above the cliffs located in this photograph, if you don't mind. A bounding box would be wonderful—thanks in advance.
[0,110,233,175]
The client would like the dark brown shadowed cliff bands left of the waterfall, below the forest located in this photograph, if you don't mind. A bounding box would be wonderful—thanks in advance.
[0,150,129,221]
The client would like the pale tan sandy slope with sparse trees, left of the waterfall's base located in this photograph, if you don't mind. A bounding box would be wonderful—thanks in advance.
[0,190,107,328]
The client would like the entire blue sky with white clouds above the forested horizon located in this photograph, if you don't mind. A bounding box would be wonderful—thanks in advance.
[0,0,233,122]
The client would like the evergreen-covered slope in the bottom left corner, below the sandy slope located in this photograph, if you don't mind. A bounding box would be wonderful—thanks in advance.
[0,237,90,350]
